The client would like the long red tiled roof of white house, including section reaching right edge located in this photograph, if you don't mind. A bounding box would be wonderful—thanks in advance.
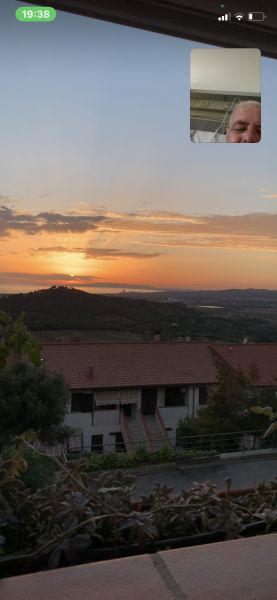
[42,342,277,389]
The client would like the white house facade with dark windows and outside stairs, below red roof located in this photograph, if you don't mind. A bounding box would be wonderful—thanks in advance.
[65,386,207,452]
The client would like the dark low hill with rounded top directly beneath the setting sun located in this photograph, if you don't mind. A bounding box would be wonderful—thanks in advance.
[0,287,194,330]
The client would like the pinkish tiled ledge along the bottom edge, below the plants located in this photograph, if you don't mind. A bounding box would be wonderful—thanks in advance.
[0,534,277,600]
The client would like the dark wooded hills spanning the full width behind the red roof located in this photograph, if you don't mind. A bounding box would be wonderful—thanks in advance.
[0,287,277,342]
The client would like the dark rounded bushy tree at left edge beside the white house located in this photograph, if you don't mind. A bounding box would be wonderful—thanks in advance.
[0,362,68,446]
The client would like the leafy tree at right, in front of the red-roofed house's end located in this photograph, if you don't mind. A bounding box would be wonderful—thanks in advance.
[194,350,276,433]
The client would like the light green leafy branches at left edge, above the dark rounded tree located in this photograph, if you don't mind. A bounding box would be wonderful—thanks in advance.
[0,311,40,368]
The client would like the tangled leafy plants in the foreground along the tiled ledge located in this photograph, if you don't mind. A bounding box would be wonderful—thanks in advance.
[0,438,277,577]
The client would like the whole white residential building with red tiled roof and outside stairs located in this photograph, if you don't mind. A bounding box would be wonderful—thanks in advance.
[42,341,277,452]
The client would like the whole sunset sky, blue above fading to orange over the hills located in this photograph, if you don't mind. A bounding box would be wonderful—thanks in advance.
[0,0,277,292]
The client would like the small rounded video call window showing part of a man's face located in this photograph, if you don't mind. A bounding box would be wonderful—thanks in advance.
[190,48,261,143]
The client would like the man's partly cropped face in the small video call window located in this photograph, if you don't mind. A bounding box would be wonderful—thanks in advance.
[226,104,261,144]
